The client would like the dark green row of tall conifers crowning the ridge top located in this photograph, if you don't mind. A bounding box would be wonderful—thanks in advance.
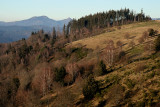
[71,8,151,35]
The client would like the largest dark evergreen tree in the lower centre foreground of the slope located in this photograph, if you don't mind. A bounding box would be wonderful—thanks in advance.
[83,76,99,100]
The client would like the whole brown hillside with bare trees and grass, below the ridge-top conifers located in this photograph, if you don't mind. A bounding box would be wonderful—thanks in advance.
[0,21,160,107]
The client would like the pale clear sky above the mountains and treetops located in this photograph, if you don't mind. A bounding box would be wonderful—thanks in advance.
[0,0,160,21]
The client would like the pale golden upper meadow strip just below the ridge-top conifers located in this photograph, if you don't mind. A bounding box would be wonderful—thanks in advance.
[69,21,160,50]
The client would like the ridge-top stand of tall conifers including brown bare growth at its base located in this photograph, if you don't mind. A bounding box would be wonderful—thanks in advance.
[67,8,151,40]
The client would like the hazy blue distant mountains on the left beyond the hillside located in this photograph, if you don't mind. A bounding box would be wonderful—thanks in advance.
[0,16,72,43]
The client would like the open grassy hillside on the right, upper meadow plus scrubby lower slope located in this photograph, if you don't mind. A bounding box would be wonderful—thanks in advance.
[63,21,160,107]
